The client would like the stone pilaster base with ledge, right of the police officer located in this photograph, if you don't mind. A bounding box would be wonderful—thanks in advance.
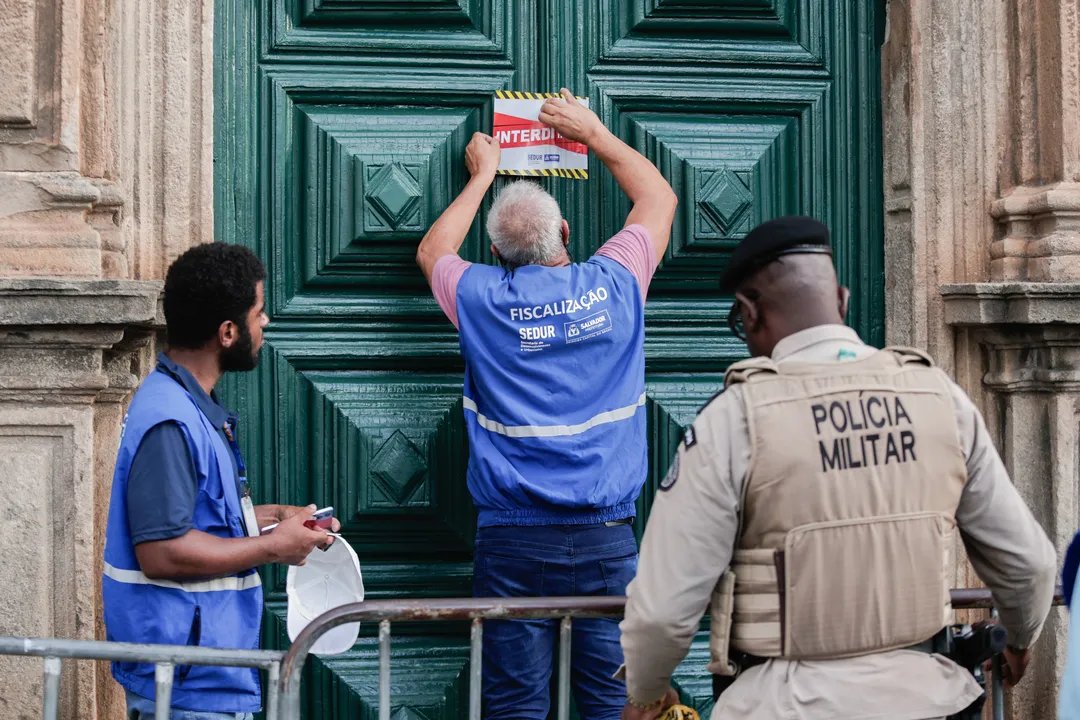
[942,283,1080,718]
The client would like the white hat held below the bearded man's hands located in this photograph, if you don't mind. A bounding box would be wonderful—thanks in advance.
[285,535,364,655]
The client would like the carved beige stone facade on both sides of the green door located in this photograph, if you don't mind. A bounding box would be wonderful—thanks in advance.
[0,0,1080,719]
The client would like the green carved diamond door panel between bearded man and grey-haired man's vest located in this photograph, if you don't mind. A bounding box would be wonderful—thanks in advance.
[260,345,476,597]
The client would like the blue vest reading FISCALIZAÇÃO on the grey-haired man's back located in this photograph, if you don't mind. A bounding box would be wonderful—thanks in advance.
[457,256,648,527]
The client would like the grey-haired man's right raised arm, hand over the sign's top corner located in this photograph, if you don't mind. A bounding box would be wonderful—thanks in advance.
[540,87,678,263]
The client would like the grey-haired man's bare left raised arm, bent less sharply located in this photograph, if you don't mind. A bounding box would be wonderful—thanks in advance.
[416,133,501,284]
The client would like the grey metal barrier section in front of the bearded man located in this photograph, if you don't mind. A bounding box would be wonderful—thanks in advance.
[0,637,285,720]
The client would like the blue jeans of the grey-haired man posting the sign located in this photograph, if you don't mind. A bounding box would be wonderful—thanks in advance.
[473,524,637,720]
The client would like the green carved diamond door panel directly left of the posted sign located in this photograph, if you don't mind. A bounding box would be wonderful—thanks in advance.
[260,67,507,317]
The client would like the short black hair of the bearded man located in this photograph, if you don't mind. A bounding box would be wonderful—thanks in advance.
[164,243,267,350]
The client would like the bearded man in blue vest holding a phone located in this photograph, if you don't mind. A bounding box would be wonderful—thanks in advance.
[102,243,340,720]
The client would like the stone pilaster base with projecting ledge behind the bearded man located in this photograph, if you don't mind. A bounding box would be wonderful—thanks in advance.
[0,280,161,718]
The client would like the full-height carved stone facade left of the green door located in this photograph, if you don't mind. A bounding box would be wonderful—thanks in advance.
[0,0,214,719]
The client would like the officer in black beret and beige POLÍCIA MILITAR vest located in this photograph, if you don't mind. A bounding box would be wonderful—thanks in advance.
[621,217,1056,720]
